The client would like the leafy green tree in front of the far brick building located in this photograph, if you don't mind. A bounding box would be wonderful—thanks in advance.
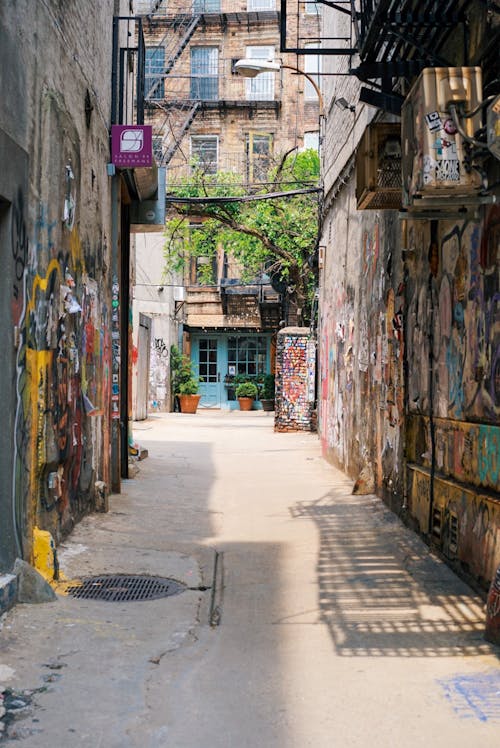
[165,150,319,321]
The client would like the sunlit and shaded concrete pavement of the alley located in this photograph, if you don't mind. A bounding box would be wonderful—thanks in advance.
[0,411,500,748]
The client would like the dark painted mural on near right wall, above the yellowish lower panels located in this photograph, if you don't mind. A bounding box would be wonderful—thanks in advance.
[407,207,500,423]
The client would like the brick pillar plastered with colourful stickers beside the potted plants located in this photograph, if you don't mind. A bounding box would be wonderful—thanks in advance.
[274,327,316,431]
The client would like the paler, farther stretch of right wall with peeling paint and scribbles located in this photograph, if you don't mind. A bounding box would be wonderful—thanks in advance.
[318,179,404,504]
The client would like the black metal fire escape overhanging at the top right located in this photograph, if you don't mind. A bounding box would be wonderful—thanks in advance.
[281,0,500,115]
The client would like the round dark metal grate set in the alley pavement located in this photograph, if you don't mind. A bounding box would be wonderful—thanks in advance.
[67,574,186,603]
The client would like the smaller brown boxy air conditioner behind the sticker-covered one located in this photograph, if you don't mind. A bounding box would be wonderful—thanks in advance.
[356,122,401,210]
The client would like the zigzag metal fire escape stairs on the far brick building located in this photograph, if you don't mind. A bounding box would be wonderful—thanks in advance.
[145,14,201,166]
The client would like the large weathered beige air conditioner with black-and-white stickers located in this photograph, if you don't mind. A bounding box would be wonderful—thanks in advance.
[401,67,482,209]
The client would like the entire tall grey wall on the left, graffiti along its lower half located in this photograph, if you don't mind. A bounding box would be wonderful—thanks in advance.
[0,0,113,567]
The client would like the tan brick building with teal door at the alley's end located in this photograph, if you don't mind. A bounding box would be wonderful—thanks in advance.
[136,0,319,407]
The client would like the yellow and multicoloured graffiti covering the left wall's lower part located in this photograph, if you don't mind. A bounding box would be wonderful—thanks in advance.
[13,199,110,553]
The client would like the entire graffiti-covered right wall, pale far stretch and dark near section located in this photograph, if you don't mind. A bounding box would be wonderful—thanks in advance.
[318,180,500,587]
